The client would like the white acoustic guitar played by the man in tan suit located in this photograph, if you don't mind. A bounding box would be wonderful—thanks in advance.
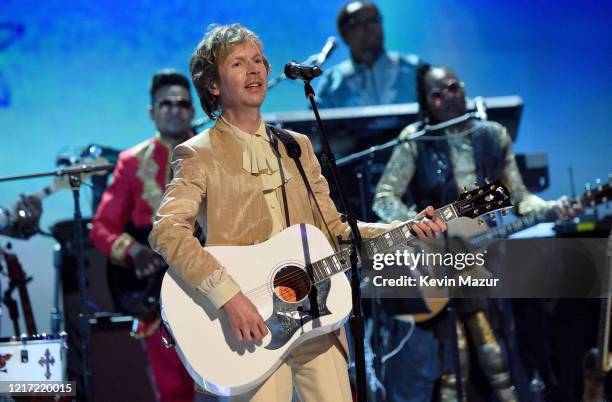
[161,182,511,395]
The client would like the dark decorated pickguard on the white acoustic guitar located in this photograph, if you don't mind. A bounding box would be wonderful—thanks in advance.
[265,279,331,350]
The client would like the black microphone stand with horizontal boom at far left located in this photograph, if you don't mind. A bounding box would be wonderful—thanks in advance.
[0,164,115,401]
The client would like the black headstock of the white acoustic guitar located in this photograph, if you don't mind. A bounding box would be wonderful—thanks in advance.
[453,179,512,223]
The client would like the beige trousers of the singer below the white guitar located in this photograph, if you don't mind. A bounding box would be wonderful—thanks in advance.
[229,334,352,402]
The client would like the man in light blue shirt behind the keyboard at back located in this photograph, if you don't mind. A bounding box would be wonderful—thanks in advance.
[316,0,419,108]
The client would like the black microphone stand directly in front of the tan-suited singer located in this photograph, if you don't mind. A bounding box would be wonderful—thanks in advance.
[304,79,367,402]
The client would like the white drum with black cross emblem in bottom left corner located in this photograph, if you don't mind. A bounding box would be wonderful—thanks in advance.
[0,332,68,382]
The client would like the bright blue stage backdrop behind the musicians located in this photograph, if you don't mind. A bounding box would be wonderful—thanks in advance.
[0,0,612,335]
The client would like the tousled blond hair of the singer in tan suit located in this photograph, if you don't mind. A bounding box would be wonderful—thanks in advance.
[189,24,270,119]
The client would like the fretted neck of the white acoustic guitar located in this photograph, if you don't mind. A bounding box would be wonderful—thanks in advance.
[309,204,458,283]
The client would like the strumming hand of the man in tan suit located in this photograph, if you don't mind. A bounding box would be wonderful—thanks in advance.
[222,292,268,343]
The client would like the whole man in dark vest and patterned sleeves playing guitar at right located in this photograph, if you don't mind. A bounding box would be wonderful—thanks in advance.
[373,64,574,402]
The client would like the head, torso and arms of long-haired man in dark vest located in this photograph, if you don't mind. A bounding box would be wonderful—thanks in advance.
[373,64,570,229]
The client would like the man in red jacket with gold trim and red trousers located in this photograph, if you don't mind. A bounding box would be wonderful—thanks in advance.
[90,69,195,402]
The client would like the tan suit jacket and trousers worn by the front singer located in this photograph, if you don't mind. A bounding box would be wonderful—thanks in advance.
[149,121,390,402]
